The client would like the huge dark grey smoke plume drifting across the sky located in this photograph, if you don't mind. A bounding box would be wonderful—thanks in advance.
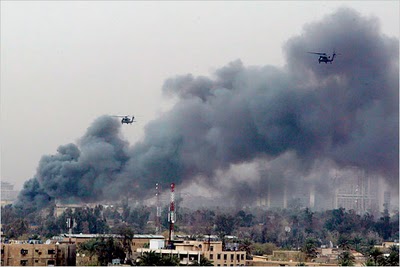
[15,8,399,210]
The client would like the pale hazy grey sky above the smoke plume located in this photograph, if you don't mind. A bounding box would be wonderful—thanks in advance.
[0,1,399,191]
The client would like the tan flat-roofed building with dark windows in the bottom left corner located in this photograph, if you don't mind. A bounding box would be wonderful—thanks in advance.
[1,243,76,266]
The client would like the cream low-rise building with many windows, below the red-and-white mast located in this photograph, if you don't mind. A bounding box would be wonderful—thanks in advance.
[136,240,246,266]
